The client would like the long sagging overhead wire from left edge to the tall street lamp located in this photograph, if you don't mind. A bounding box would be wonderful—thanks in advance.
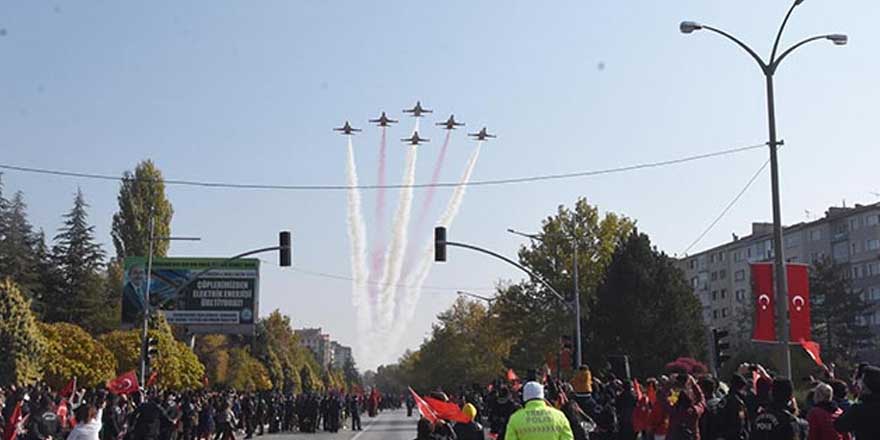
[0,144,765,191]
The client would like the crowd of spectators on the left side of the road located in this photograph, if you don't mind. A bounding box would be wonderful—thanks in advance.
[0,384,401,440]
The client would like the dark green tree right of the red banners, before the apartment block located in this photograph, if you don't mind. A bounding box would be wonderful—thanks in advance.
[810,258,874,368]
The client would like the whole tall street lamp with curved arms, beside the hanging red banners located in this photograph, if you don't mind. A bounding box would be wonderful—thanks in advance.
[679,0,848,377]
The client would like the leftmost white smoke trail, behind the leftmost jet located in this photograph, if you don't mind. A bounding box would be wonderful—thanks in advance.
[345,135,373,358]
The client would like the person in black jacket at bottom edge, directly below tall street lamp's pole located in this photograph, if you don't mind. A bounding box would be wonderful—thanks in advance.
[751,378,802,440]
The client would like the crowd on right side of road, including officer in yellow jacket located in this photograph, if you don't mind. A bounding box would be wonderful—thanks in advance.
[416,364,880,440]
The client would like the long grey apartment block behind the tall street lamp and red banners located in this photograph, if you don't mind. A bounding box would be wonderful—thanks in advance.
[678,203,880,347]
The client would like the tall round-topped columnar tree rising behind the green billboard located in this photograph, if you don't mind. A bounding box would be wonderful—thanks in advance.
[110,159,174,261]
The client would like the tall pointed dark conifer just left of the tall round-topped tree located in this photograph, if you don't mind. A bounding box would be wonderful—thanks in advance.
[47,190,106,330]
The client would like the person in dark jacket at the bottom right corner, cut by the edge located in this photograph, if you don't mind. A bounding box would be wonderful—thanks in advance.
[834,366,880,440]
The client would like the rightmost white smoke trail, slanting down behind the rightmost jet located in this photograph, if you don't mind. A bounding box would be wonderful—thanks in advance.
[384,141,483,350]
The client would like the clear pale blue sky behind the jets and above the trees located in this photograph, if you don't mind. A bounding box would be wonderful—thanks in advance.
[0,0,880,368]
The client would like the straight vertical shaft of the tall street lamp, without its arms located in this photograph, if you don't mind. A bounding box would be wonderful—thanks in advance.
[765,72,791,378]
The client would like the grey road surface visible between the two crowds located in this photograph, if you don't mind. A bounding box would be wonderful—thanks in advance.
[262,410,419,440]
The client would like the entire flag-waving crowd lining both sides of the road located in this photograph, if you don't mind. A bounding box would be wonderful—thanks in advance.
[0,364,880,440]
